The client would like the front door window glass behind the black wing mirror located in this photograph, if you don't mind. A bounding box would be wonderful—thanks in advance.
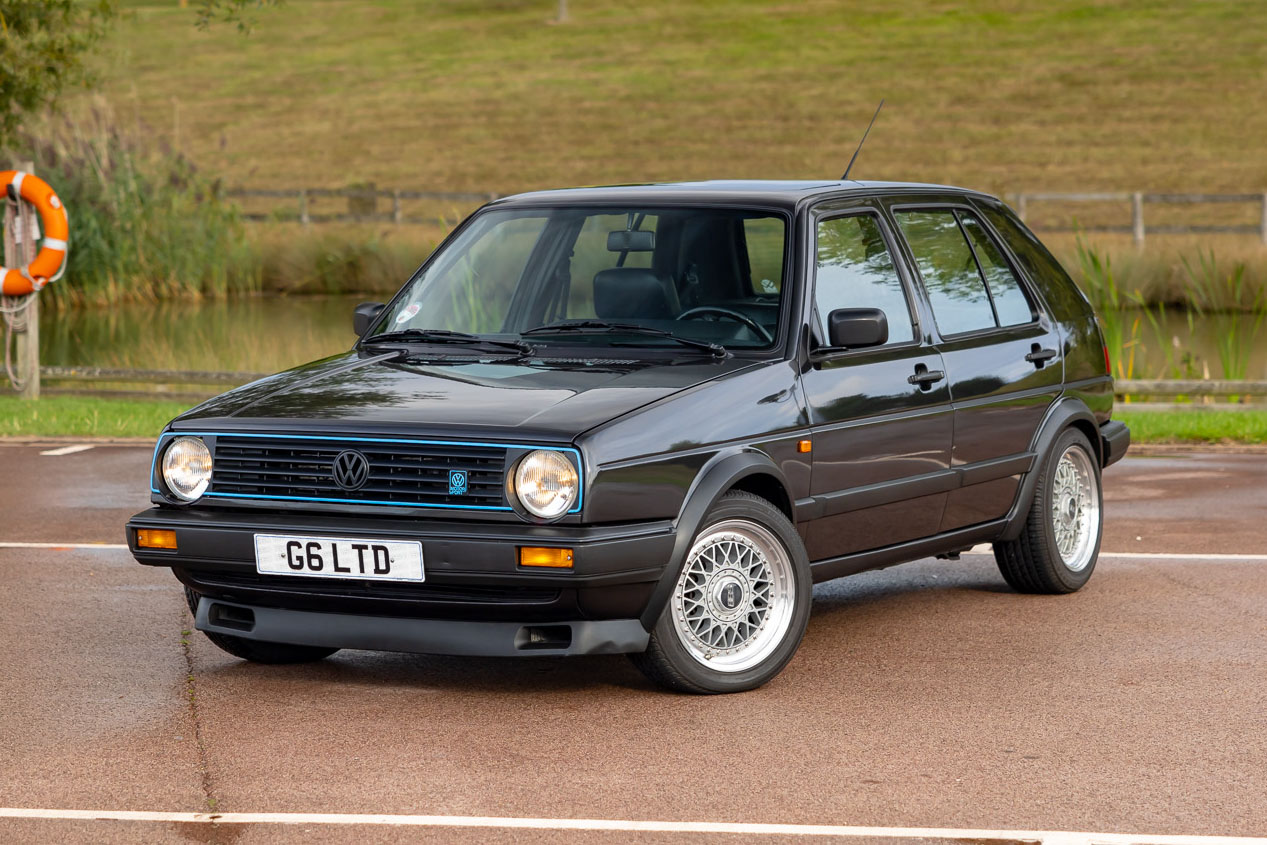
[813,214,915,343]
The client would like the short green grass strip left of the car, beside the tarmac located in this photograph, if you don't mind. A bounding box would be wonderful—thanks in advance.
[0,397,189,438]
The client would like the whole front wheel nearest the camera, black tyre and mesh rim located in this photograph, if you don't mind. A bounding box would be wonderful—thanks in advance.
[630,490,813,693]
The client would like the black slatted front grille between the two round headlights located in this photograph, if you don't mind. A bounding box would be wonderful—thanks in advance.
[208,435,508,509]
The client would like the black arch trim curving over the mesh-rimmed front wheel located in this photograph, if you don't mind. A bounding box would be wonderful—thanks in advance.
[641,447,796,631]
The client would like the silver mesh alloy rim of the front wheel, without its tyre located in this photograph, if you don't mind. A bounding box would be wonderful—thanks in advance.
[670,519,794,673]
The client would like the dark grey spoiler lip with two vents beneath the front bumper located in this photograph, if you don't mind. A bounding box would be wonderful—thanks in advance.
[194,595,650,658]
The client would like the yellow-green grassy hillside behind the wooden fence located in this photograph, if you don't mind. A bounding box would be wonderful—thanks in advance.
[81,0,1267,191]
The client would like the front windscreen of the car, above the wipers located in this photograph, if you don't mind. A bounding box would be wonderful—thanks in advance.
[375,206,787,350]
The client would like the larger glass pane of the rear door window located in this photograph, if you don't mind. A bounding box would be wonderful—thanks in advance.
[896,209,997,334]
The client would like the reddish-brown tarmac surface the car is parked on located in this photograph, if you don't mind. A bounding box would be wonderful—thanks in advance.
[0,443,1267,844]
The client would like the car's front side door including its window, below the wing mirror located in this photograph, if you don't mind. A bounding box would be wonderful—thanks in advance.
[802,206,955,562]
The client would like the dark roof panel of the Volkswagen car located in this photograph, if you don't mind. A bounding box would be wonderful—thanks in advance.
[493,179,988,208]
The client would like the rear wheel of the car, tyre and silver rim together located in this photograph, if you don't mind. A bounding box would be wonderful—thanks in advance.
[995,428,1104,593]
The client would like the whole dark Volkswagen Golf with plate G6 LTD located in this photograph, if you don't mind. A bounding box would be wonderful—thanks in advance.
[127,181,1130,693]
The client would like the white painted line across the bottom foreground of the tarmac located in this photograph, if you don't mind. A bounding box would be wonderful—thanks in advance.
[0,807,1267,845]
